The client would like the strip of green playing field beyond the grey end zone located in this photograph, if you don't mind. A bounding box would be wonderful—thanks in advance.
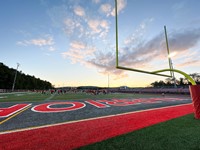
[0,92,167,102]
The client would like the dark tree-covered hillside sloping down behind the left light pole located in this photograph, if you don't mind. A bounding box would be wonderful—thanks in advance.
[0,63,53,90]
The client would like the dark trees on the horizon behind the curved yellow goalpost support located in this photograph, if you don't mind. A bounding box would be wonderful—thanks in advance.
[150,73,200,87]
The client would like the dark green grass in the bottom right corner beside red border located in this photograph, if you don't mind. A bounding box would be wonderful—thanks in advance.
[80,114,200,150]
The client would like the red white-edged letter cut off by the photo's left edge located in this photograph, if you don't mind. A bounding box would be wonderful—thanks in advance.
[0,104,31,118]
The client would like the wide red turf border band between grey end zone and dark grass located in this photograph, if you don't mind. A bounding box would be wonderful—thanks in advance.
[0,104,193,150]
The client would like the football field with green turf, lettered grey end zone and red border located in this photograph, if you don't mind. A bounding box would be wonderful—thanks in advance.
[0,93,198,149]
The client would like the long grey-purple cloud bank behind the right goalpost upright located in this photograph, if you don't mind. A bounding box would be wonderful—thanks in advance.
[120,29,200,66]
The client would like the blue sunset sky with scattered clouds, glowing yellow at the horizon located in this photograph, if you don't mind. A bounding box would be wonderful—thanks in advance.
[0,0,200,87]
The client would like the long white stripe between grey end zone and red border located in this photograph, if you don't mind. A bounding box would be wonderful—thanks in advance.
[0,103,192,135]
